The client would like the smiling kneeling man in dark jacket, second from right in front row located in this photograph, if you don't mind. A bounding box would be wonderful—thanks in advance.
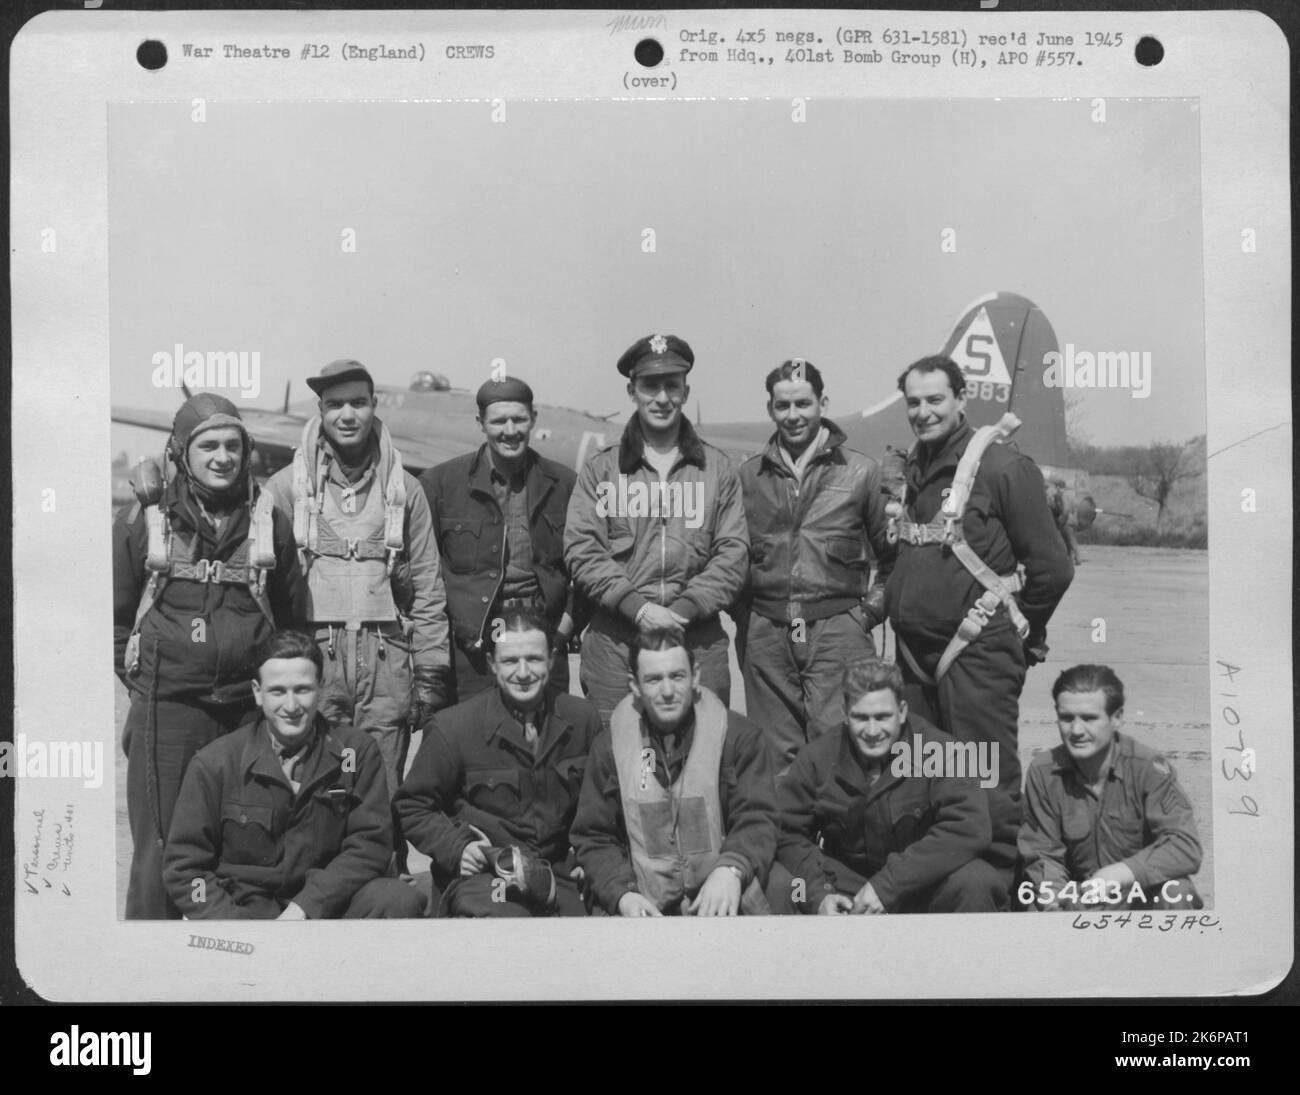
[767,658,1008,916]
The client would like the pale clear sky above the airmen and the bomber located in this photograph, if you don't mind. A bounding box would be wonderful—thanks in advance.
[109,99,1205,455]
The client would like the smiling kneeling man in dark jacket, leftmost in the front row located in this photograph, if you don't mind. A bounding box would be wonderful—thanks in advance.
[163,631,424,919]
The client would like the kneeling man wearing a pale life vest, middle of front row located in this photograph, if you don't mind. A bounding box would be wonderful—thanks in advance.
[573,629,776,917]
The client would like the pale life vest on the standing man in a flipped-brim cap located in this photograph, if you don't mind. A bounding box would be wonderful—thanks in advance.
[294,416,407,631]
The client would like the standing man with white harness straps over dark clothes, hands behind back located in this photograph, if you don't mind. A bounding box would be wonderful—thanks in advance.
[885,356,1074,888]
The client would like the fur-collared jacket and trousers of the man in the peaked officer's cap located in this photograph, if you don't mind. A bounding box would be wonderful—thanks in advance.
[564,416,749,724]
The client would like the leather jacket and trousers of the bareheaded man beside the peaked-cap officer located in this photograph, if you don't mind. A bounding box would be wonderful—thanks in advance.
[737,419,896,770]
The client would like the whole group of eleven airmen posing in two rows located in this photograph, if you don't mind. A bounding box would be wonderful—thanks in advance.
[113,334,1201,919]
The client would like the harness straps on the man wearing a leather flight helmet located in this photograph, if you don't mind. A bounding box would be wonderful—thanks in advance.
[124,456,276,676]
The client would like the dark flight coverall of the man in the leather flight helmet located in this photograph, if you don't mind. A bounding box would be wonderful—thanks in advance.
[112,476,306,919]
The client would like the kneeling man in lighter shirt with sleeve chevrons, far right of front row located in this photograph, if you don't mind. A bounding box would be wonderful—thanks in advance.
[1017,666,1204,912]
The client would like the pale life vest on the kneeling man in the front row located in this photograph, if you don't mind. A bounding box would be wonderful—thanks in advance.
[610,688,727,910]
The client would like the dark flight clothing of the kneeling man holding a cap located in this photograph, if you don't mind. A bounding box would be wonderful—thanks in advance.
[393,688,601,917]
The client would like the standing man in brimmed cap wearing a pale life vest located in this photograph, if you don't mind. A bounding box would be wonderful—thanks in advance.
[267,360,447,796]
